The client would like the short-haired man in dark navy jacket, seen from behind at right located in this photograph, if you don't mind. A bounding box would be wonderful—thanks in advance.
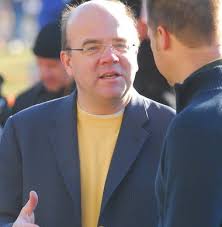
[147,0,222,227]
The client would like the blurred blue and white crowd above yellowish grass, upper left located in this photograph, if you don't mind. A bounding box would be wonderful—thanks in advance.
[0,0,69,48]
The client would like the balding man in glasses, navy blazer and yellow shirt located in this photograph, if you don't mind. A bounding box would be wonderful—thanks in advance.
[0,0,174,227]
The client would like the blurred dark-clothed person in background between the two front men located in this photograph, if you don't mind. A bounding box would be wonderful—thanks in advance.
[129,0,175,108]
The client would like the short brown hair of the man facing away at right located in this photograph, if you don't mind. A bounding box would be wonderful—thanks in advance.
[147,0,222,47]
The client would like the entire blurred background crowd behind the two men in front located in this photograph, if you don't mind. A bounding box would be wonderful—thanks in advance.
[0,0,175,137]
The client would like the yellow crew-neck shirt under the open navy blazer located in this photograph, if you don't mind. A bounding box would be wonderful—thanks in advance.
[77,106,123,227]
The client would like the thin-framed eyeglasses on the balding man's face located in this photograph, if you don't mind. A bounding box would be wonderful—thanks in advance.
[65,43,136,56]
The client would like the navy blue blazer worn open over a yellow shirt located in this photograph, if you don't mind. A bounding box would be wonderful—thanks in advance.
[0,89,174,227]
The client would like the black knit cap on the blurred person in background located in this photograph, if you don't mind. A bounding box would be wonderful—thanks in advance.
[33,23,61,59]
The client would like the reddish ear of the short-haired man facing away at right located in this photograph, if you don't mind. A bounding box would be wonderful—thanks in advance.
[157,26,170,50]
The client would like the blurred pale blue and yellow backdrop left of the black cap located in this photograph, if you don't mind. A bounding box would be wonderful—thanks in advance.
[0,0,63,106]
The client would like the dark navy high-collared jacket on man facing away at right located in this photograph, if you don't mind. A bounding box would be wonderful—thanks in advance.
[156,60,222,227]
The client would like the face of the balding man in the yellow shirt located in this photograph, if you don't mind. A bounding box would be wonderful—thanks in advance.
[63,5,138,106]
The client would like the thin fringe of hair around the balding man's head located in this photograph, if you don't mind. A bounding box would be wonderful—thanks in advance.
[61,0,137,50]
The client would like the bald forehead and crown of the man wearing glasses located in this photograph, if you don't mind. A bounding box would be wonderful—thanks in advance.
[67,0,137,45]
